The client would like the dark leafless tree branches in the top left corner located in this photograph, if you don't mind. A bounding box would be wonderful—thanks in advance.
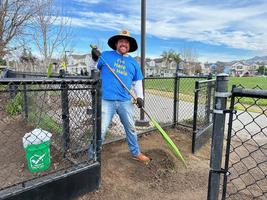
[0,0,35,57]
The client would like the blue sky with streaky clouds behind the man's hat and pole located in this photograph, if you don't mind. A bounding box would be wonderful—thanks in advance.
[57,0,267,62]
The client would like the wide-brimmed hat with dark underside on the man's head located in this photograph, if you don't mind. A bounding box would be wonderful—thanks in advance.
[108,29,138,52]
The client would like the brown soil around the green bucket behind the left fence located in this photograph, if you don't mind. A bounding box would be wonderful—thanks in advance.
[0,94,69,190]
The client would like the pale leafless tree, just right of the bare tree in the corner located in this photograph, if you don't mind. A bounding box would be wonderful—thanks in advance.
[31,0,71,71]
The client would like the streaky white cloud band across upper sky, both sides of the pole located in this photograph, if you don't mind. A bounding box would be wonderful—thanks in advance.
[68,0,267,57]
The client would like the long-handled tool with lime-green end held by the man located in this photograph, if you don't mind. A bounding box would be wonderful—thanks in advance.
[90,45,187,168]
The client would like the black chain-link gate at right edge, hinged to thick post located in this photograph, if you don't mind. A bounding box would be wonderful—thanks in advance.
[222,87,267,200]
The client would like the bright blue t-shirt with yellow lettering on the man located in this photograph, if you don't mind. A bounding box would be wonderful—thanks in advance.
[97,51,143,101]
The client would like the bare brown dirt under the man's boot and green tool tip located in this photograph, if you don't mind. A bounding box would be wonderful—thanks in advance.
[78,129,213,200]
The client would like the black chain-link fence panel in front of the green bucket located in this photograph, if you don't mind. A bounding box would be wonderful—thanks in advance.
[0,79,101,198]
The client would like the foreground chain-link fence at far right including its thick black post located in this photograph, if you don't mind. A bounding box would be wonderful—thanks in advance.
[208,77,267,200]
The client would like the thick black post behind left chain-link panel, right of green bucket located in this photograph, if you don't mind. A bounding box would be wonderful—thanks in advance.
[60,81,70,156]
